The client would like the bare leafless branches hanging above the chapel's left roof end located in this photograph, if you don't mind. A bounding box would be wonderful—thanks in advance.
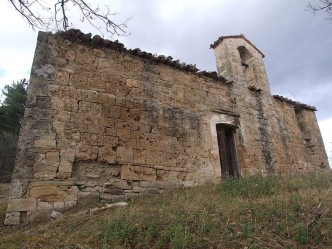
[9,0,129,36]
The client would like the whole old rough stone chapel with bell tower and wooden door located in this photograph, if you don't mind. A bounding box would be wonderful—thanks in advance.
[5,30,329,225]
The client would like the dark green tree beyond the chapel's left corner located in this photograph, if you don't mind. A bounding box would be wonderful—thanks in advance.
[0,79,28,182]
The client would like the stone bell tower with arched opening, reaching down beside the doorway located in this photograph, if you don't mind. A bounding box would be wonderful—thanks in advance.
[211,35,278,174]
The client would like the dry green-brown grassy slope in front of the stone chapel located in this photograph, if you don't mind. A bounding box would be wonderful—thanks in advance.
[0,173,332,248]
